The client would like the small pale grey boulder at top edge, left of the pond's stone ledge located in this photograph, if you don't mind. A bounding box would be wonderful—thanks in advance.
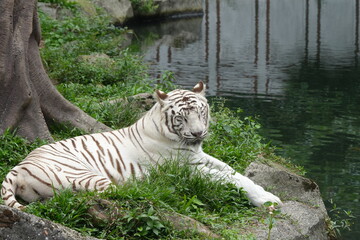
[93,0,134,24]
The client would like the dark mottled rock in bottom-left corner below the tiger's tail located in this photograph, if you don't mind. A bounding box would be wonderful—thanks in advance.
[0,205,97,240]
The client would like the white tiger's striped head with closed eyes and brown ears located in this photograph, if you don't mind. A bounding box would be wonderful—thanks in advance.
[155,82,210,145]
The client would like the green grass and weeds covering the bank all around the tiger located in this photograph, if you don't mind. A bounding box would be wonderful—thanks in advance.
[0,1,286,239]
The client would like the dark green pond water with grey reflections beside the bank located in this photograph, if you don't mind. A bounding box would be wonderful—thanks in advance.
[131,0,360,239]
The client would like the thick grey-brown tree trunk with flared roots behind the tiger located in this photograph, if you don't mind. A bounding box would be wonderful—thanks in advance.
[0,0,110,141]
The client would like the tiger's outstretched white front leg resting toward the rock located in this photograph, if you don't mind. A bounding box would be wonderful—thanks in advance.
[193,154,282,207]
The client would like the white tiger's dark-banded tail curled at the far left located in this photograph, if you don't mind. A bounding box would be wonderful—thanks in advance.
[1,170,25,210]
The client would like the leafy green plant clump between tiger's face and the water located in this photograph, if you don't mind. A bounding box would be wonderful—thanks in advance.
[204,100,271,171]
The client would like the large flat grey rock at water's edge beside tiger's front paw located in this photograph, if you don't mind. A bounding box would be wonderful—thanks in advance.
[245,163,329,240]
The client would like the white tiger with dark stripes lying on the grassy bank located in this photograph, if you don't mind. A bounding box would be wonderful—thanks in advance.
[1,82,281,209]
